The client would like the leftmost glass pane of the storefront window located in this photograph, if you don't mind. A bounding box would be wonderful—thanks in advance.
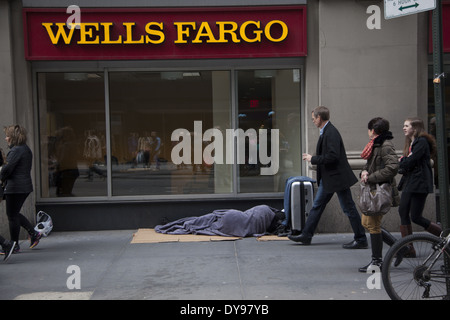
[38,73,107,198]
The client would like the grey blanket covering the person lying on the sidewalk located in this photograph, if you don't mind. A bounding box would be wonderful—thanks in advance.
[155,205,275,237]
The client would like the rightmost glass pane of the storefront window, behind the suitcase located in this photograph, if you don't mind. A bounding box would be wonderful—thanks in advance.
[237,69,301,193]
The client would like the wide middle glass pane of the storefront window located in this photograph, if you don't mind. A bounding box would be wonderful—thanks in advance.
[109,71,232,195]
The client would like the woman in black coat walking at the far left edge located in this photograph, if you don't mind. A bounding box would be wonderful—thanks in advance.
[0,125,42,252]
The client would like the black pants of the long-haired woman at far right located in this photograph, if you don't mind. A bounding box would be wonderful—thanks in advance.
[398,192,430,229]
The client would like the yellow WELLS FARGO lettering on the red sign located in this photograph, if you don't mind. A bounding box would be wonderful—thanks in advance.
[42,20,289,45]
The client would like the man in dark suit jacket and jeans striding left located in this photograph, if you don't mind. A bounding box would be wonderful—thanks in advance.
[289,106,368,249]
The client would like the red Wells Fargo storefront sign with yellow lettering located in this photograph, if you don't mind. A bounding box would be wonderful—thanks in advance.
[23,6,307,60]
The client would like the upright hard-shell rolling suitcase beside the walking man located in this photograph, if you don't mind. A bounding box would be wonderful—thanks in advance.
[290,181,314,231]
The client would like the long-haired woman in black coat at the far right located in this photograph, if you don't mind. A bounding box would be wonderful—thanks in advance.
[398,118,442,242]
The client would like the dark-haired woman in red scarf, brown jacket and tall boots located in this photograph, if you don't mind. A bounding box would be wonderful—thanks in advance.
[359,117,399,272]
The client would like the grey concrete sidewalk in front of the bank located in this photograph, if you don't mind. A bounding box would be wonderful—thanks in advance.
[0,230,389,301]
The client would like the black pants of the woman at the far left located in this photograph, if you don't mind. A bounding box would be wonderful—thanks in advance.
[5,193,34,242]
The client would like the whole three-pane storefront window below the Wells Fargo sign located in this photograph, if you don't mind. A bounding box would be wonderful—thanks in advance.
[37,69,301,198]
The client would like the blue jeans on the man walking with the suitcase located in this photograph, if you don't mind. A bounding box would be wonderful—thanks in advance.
[302,183,367,242]
